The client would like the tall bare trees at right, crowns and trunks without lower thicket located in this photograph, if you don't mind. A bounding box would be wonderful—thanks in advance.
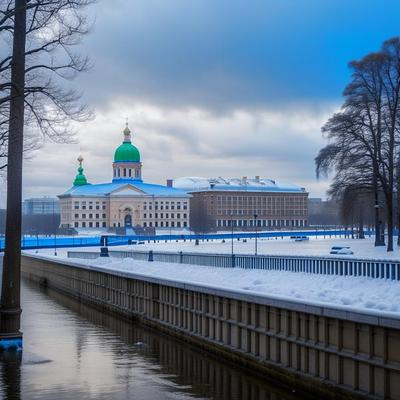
[316,37,400,251]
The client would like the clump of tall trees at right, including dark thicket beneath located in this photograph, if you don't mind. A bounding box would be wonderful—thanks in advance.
[315,37,400,251]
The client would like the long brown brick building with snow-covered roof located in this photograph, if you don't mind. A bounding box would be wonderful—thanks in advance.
[173,176,308,232]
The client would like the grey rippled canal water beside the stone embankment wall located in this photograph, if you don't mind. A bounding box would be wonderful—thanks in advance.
[0,282,310,400]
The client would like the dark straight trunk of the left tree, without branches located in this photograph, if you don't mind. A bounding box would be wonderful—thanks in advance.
[0,0,26,339]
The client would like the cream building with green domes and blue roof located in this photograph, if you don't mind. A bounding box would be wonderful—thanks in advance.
[58,125,190,233]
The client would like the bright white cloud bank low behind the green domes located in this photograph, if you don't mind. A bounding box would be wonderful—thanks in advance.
[20,98,335,202]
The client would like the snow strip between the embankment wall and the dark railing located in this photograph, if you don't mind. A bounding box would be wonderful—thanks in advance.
[27,242,400,318]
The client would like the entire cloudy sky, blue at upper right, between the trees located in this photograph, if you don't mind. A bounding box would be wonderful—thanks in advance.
[14,0,400,198]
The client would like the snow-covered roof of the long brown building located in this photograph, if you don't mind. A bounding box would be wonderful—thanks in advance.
[173,177,306,193]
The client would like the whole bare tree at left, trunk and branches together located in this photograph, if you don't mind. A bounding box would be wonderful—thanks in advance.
[0,0,92,344]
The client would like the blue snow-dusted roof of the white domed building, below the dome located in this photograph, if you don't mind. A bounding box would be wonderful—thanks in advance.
[59,179,189,197]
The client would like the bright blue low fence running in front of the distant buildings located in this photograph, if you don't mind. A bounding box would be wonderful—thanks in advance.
[0,229,372,251]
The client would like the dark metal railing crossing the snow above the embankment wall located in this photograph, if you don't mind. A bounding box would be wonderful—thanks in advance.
[68,250,400,281]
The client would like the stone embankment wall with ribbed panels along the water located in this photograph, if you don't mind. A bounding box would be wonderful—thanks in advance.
[22,256,400,399]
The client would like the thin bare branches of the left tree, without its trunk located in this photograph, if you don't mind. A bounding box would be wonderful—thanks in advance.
[0,0,95,169]
